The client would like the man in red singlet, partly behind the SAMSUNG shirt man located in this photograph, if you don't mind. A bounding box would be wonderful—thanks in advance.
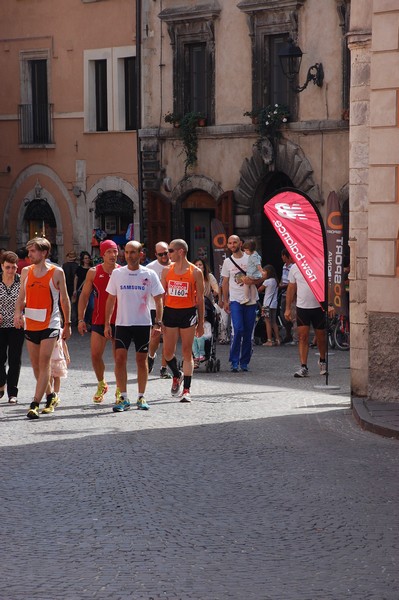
[78,240,119,404]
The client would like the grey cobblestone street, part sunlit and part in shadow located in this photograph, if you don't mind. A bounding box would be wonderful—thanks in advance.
[0,331,399,600]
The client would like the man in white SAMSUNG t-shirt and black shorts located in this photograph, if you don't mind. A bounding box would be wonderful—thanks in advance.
[104,241,164,412]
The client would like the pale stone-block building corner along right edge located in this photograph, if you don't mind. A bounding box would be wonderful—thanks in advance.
[348,0,399,402]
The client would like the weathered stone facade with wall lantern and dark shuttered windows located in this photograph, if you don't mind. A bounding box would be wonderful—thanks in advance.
[140,0,350,268]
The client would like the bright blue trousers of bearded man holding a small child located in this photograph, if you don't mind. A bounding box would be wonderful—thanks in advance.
[229,302,256,368]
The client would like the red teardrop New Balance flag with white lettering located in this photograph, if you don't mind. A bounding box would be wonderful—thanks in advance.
[264,189,327,308]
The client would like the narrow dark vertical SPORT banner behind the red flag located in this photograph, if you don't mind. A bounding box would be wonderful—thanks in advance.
[326,192,348,315]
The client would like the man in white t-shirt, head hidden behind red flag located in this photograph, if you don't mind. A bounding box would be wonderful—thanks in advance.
[284,264,327,377]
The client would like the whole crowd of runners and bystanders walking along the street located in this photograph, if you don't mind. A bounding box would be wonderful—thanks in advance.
[0,235,327,419]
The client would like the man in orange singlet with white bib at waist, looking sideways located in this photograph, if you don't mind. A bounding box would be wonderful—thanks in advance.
[14,238,71,419]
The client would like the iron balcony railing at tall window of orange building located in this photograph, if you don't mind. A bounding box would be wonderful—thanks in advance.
[19,104,54,146]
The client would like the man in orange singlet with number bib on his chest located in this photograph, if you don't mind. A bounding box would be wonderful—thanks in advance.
[161,239,204,402]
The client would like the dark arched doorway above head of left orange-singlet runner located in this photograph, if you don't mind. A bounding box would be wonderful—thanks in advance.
[24,198,58,262]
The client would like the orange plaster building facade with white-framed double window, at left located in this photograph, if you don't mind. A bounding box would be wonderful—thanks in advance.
[0,0,140,262]
